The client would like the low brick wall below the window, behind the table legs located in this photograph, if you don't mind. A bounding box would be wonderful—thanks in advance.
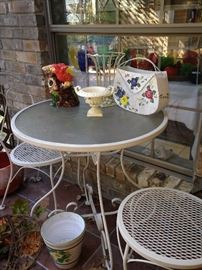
[65,154,193,199]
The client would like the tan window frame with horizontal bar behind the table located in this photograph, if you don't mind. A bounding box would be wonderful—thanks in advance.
[46,0,202,181]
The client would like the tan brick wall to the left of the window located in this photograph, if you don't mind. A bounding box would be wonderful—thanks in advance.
[0,0,49,109]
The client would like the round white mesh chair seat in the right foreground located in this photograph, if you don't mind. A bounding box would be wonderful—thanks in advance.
[117,188,202,269]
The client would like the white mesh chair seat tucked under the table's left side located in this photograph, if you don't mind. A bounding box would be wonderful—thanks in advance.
[10,143,61,167]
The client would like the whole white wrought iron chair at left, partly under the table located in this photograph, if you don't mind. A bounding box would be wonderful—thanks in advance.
[0,90,64,215]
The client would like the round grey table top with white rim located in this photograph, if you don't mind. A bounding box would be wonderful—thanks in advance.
[11,99,168,152]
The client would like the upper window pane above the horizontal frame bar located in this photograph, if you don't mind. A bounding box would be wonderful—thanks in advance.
[50,0,202,25]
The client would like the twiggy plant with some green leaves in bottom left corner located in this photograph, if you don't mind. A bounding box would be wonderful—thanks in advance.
[0,199,44,270]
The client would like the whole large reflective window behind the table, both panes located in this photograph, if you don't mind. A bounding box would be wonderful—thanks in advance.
[47,0,202,179]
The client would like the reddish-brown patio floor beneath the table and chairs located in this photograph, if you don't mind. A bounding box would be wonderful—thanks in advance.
[0,172,202,270]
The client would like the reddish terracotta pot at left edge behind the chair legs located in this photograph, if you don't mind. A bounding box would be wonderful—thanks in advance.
[0,151,24,197]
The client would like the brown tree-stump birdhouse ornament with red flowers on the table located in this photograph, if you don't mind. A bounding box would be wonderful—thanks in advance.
[42,63,79,107]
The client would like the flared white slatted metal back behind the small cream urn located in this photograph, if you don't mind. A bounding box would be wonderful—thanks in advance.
[87,52,125,86]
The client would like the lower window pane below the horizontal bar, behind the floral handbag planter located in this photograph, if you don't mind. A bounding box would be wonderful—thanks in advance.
[56,32,202,172]
